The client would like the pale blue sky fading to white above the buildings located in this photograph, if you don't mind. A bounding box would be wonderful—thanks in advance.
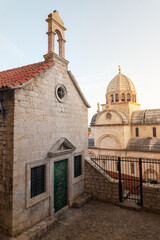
[0,0,160,123]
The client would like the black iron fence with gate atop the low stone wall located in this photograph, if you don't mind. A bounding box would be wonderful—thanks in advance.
[91,156,160,205]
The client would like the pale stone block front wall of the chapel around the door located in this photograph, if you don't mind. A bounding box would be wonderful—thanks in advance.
[12,56,88,235]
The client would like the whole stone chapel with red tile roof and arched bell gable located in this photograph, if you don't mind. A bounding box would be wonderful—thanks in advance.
[0,11,90,236]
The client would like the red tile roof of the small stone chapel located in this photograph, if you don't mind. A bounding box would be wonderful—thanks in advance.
[0,62,53,88]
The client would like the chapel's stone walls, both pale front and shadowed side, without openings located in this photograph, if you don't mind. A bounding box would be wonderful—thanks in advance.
[0,55,88,235]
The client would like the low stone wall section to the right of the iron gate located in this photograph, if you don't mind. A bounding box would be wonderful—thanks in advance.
[143,184,160,214]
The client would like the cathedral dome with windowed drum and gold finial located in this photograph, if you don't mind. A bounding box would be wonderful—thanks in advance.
[106,68,137,105]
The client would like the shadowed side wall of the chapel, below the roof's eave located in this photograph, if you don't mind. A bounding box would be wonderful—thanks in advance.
[0,91,14,232]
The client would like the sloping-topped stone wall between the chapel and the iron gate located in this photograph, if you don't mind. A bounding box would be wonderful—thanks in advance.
[85,159,119,203]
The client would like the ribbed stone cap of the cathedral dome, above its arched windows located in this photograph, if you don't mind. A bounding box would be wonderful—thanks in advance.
[107,73,136,93]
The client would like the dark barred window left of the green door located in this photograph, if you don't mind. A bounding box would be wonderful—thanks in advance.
[30,165,46,198]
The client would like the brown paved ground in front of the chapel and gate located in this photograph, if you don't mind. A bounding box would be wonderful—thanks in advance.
[42,200,160,240]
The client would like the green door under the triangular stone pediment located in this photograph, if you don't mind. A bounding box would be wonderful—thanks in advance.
[54,159,67,212]
